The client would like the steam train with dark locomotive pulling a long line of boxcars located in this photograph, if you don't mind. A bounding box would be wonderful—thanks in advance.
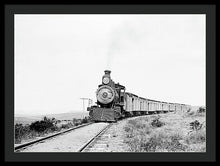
[87,70,191,122]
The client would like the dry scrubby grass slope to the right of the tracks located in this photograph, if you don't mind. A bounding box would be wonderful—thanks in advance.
[124,111,206,152]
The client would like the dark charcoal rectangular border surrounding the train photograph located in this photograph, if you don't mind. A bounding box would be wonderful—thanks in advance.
[4,4,216,162]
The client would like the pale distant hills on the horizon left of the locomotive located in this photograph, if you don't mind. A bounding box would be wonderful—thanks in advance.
[14,112,89,124]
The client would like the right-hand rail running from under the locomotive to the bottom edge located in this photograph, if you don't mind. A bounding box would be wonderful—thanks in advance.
[77,123,113,152]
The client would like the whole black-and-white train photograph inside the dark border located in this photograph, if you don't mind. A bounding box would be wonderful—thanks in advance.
[14,14,207,153]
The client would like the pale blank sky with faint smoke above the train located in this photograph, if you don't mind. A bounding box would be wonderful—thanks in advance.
[14,14,206,114]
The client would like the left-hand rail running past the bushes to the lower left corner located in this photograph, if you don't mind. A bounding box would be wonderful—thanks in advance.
[14,122,94,152]
